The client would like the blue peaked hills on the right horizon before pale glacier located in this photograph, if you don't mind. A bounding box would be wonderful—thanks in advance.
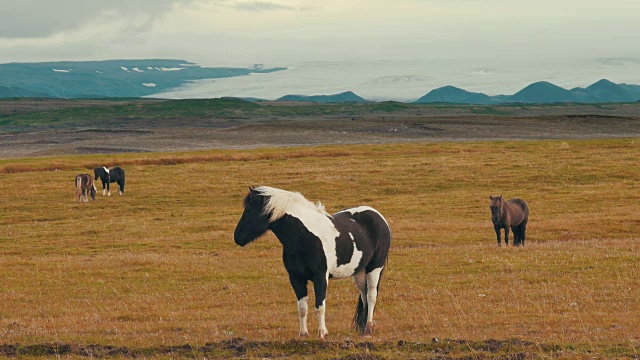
[415,79,640,104]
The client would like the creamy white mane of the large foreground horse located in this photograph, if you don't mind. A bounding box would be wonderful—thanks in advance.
[254,186,331,222]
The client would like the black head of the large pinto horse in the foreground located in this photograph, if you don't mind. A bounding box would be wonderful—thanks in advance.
[233,187,270,246]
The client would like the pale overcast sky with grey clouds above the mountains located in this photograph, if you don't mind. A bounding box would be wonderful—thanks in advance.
[0,0,640,66]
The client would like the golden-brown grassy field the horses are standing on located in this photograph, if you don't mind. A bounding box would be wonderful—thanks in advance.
[0,139,640,358]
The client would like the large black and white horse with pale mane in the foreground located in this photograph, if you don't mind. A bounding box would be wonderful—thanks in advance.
[234,186,391,339]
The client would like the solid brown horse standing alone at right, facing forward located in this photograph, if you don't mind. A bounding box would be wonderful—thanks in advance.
[489,195,529,246]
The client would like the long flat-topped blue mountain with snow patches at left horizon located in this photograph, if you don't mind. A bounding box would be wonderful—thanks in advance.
[0,59,286,98]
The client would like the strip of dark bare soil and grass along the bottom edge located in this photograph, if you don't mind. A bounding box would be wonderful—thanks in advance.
[0,338,624,360]
